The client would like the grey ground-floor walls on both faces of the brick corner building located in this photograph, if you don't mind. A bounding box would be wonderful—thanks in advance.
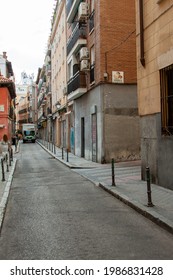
[74,84,140,162]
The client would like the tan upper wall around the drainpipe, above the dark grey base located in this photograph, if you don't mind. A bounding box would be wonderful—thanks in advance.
[136,0,173,116]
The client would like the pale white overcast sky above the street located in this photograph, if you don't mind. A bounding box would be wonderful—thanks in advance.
[0,0,56,83]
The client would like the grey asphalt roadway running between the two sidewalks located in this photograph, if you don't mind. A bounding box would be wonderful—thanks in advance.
[0,143,173,260]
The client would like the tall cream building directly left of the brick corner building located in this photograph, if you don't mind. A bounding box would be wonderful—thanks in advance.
[50,0,68,148]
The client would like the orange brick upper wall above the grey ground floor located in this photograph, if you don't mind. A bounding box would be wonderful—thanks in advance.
[88,0,136,83]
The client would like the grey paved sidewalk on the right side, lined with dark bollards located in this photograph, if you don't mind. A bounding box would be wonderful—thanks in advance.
[38,142,173,233]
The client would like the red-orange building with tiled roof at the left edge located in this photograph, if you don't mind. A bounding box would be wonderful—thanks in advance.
[0,75,16,139]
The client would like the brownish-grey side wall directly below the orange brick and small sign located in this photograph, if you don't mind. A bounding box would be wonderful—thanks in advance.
[104,84,140,162]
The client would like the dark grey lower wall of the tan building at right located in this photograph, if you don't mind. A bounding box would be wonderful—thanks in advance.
[140,113,173,190]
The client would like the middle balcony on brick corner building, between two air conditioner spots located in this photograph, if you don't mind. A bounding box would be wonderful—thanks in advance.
[67,23,87,55]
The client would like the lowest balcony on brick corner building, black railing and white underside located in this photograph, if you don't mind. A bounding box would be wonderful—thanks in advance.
[67,71,87,101]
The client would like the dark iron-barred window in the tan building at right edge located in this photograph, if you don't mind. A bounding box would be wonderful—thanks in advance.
[160,64,173,135]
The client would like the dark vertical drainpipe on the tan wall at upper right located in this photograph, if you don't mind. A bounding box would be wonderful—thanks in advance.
[139,0,145,67]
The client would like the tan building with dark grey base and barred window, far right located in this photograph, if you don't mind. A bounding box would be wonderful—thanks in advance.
[136,0,173,189]
